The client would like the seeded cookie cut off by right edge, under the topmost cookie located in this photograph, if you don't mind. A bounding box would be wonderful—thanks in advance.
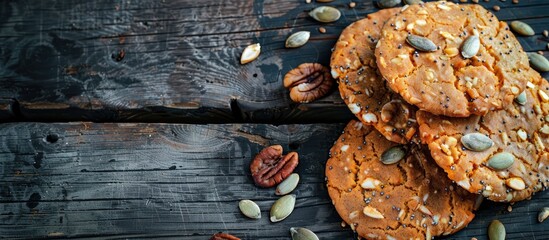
[417,70,549,202]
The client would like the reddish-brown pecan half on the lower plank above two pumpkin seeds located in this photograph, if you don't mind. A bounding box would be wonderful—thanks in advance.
[250,145,299,188]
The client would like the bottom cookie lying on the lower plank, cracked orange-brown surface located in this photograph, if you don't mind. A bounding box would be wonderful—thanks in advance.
[326,120,480,239]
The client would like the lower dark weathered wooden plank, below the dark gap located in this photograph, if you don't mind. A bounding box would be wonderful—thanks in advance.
[0,123,549,240]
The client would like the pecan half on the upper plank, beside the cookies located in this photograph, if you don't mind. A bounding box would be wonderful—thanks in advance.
[284,63,334,103]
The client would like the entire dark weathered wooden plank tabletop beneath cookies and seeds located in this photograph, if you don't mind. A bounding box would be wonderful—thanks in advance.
[0,0,549,239]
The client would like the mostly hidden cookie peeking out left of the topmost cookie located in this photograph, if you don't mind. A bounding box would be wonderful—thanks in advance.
[330,8,417,143]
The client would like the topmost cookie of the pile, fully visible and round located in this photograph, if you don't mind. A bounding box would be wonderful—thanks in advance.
[375,1,530,117]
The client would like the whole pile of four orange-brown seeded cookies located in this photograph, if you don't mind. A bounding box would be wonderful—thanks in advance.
[326,2,549,239]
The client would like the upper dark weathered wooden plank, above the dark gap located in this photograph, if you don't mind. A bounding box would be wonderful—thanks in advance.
[0,0,549,124]
